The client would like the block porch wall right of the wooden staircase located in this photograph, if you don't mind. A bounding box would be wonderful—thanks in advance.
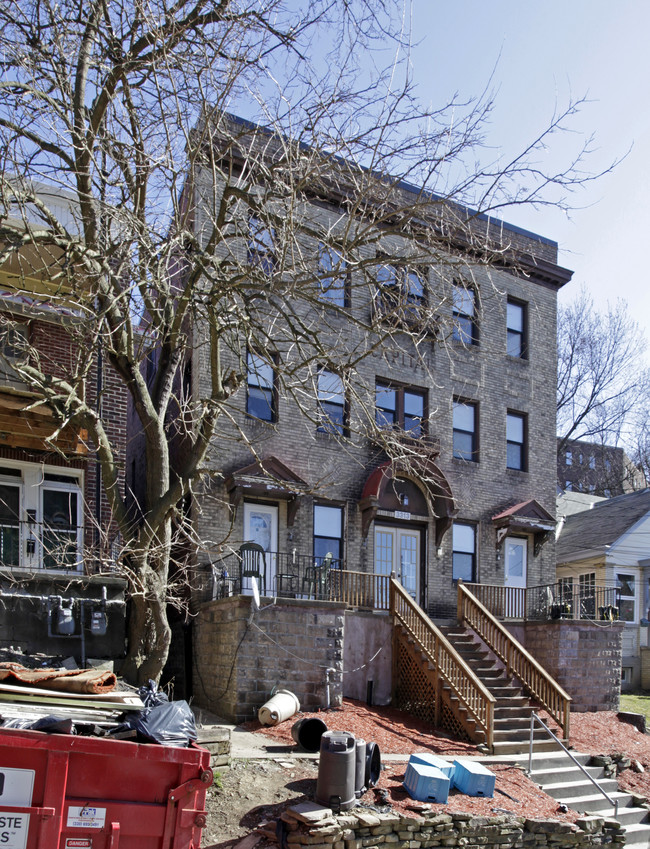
[524,620,625,711]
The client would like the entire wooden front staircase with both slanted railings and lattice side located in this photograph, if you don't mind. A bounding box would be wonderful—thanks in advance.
[390,577,571,754]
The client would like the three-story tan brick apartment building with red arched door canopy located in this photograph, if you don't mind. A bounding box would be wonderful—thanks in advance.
[180,117,571,617]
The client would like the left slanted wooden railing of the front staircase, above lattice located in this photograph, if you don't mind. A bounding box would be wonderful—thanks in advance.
[390,578,496,748]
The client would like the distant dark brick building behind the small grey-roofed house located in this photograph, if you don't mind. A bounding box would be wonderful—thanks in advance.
[557,439,647,498]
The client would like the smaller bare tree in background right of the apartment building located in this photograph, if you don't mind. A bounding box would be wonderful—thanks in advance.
[557,288,648,458]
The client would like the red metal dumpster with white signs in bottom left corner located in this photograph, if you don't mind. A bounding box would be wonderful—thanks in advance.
[0,728,212,849]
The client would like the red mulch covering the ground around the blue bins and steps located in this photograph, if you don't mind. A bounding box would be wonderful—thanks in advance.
[245,699,650,822]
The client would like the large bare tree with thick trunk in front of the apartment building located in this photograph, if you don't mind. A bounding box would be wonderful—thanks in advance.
[0,0,604,681]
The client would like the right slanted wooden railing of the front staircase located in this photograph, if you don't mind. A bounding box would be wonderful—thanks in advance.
[458,581,571,740]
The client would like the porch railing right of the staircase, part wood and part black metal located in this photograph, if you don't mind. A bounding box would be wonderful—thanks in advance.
[465,582,620,621]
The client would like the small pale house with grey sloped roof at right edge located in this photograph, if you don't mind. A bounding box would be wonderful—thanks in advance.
[556,489,650,689]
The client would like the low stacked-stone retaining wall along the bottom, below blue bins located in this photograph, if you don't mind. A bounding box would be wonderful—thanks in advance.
[265,803,625,849]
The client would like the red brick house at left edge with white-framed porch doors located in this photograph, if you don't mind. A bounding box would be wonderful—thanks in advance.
[0,184,127,661]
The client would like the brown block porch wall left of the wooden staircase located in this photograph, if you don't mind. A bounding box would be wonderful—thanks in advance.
[192,596,344,722]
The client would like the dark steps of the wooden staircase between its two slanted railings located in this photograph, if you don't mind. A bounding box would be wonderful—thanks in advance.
[438,625,556,755]
